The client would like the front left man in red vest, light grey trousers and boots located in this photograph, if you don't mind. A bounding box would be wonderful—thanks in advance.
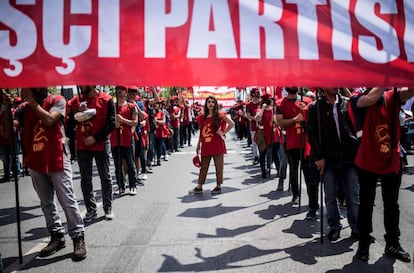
[16,88,87,261]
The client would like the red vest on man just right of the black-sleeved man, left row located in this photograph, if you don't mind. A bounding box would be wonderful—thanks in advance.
[111,103,135,147]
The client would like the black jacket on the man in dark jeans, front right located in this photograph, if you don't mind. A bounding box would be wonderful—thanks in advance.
[306,95,358,163]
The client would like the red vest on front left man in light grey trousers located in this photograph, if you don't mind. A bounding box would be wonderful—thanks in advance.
[23,95,64,173]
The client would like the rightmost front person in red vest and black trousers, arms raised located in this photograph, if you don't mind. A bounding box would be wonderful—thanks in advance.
[350,87,414,262]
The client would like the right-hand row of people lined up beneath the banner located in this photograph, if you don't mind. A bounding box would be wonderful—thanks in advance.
[231,87,414,262]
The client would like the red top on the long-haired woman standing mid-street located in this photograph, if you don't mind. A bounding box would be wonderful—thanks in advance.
[197,113,227,156]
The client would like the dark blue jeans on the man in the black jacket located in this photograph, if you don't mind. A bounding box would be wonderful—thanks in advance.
[322,162,359,233]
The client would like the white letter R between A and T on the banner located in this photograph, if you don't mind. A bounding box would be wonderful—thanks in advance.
[239,0,285,59]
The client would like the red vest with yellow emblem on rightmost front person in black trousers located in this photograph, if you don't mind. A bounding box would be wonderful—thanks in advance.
[355,91,401,174]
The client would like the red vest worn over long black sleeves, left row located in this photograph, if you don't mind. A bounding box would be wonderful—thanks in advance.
[71,92,112,152]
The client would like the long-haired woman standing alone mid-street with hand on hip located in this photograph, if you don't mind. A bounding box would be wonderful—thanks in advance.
[190,96,234,194]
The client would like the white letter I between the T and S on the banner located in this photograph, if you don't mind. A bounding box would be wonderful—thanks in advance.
[331,0,352,61]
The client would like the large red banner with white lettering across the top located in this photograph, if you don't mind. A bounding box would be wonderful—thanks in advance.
[0,0,414,87]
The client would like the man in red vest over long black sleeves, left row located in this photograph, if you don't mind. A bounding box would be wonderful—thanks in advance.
[71,85,115,222]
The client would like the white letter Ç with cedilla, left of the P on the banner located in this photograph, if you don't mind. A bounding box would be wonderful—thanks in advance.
[43,0,92,75]
